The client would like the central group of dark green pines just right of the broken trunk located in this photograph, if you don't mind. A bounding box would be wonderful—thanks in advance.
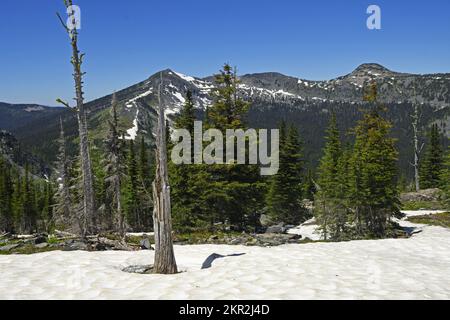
[169,65,307,231]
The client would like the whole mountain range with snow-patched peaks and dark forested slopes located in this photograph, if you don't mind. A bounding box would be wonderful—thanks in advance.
[0,63,450,175]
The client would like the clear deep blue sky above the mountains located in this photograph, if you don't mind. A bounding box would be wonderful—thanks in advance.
[0,0,450,105]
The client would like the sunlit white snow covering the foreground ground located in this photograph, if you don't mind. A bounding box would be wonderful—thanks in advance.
[0,212,450,299]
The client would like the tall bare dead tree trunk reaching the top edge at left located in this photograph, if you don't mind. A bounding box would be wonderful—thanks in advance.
[58,0,95,237]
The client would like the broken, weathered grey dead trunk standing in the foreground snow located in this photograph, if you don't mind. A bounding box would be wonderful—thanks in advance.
[153,74,178,274]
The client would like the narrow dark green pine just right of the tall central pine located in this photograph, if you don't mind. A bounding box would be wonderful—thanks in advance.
[267,124,306,224]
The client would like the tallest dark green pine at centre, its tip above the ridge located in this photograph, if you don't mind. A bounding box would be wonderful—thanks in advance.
[205,64,265,229]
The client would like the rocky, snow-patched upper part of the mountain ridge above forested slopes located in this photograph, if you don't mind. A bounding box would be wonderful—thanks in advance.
[75,64,450,139]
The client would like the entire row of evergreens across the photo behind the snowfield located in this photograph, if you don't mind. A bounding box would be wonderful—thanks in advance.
[0,65,450,240]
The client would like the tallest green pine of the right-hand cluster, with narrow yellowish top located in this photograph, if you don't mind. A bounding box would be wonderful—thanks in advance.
[349,84,399,237]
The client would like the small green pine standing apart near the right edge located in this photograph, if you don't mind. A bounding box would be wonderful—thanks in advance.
[420,124,444,189]
